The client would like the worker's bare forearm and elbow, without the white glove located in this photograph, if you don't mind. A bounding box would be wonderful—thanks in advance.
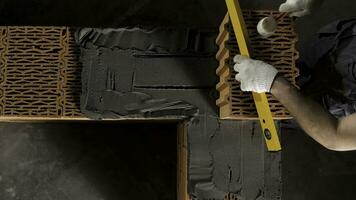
[271,76,356,151]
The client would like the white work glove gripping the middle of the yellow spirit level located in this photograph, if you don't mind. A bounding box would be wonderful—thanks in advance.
[234,55,278,93]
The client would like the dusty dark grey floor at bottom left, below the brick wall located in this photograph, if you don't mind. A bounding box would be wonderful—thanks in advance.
[0,123,177,200]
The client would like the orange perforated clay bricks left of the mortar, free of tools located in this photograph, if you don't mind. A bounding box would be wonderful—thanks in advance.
[0,26,83,119]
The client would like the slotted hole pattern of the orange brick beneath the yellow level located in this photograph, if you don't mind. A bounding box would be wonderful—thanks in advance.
[218,11,299,119]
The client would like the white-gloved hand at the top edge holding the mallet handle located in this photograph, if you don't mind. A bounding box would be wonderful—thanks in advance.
[279,0,323,17]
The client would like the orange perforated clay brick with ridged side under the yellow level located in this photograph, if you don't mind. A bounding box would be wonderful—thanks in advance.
[216,11,299,119]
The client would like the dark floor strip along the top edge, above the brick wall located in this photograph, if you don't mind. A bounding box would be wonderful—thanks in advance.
[0,0,280,27]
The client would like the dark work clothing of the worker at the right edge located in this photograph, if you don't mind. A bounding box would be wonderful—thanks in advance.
[300,19,356,117]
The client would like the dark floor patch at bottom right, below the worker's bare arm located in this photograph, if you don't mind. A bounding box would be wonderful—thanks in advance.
[282,122,356,200]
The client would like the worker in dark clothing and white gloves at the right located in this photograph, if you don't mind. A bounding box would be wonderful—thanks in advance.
[234,0,356,151]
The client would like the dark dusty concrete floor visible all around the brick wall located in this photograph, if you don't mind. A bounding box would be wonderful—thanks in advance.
[0,0,356,200]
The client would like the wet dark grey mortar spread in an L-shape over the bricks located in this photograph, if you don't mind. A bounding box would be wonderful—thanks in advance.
[76,28,281,200]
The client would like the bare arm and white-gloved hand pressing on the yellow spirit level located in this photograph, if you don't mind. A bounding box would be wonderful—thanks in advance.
[234,56,356,151]
